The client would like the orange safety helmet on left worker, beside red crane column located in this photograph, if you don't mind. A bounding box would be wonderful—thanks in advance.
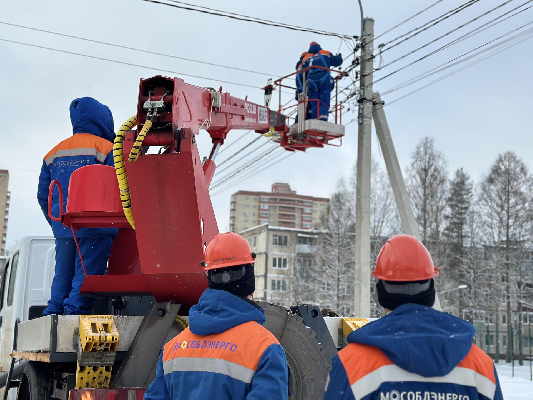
[201,232,255,271]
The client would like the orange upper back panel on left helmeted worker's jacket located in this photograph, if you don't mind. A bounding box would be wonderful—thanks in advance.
[163,321,279,371]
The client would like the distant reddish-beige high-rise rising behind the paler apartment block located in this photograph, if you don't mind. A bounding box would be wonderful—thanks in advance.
[230,182,329,233]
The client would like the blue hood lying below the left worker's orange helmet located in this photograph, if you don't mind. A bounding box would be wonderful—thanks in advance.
[189,289,265,335]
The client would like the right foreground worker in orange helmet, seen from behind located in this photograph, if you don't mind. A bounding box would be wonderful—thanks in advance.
[324,235,503,400]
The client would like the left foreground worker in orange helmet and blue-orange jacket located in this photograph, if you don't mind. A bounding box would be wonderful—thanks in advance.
[144,232,288,400]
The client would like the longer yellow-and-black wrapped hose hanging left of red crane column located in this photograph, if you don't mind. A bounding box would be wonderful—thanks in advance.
[113,115,137,229]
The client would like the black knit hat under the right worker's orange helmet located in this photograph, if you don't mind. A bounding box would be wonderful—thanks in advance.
[376,279,435,310]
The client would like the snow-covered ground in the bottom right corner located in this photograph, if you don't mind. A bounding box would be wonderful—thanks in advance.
[496,361,533,400]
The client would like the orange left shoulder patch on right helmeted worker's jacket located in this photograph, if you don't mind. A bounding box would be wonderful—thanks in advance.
[339,343,392,385]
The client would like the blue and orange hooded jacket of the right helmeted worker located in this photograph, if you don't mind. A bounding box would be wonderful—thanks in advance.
[324,304,502,400]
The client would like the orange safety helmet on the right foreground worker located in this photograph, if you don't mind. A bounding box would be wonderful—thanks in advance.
[372,235,439,282]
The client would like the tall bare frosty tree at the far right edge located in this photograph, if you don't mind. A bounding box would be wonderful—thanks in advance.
[479,152,532,362]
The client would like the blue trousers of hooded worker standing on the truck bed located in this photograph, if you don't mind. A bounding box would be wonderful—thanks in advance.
[43,236,114,315]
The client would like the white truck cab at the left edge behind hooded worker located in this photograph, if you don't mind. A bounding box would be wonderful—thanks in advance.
[0,236,55,399]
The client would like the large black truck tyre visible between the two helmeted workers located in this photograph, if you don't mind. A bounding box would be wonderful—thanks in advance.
[258,302,330,400]
